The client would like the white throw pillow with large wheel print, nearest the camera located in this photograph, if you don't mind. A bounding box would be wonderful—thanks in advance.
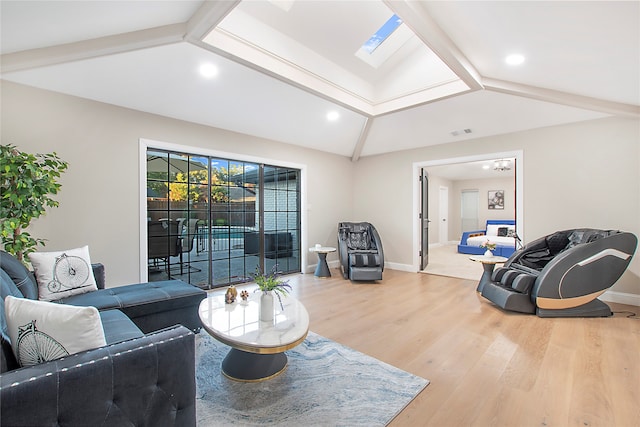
[4,295,107,366]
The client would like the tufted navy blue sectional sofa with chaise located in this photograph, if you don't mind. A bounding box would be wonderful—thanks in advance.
[0,251,206,426]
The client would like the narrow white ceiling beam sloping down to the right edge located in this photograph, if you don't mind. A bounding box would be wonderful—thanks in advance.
[482,78,640,118]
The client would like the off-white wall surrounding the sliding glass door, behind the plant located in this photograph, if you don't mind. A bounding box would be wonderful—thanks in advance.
[0,81,353,286]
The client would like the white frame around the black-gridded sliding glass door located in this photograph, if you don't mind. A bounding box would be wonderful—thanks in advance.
[138,138,308,283]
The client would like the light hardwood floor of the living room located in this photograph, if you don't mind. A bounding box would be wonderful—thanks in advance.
[287,270,640,427]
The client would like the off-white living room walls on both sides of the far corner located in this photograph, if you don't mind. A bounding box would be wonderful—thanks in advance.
[0,82,640,300]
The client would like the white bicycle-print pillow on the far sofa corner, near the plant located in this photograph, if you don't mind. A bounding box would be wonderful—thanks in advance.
[29,246,98,301]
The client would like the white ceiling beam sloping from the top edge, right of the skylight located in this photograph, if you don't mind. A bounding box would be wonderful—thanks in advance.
[383,0,482,90]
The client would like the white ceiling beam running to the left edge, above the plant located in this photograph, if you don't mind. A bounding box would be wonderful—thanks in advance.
[0,23,186,73]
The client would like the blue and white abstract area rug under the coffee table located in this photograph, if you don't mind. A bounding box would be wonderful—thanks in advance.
[196,331,429,427]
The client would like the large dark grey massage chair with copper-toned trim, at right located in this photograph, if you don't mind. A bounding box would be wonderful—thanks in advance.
[480,228,638,317]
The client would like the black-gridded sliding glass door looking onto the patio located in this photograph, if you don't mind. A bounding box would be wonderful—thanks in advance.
[147,149,301,288]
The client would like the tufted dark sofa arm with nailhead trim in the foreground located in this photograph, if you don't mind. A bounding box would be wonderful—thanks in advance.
[0,326,195,426]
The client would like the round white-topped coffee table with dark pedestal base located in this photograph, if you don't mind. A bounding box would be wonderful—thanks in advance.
[198,289,309,381]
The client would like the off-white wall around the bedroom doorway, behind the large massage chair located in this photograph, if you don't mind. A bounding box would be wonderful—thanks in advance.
[354,118,640,294]
